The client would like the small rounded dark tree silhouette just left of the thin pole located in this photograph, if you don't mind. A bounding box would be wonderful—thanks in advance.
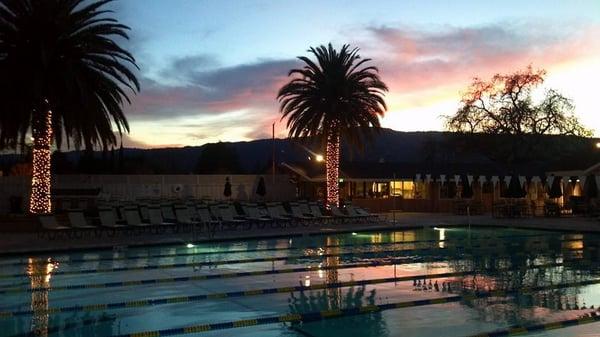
[196,142,242,174]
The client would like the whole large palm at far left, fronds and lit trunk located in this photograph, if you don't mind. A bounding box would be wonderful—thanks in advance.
[0,0,139,213]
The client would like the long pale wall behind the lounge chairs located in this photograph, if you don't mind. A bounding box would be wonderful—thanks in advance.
[0,175,296,214]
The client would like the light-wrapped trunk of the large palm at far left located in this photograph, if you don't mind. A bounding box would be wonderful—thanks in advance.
[29,109,52,214]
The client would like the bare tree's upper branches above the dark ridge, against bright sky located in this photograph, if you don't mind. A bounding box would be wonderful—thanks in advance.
[446,66,592,136]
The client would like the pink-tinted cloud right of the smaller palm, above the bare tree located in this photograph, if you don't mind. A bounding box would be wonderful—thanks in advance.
[367,25,600,94]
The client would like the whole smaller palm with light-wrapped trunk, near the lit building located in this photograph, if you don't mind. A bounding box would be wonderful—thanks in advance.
[277,44,388,206]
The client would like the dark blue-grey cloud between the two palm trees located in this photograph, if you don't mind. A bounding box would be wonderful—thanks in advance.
[129,56,298,119]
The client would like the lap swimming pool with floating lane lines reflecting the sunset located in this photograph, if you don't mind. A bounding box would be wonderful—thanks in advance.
[0,228,600,337]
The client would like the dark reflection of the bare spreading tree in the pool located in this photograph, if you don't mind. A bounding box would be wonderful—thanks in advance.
[449,232,600,325]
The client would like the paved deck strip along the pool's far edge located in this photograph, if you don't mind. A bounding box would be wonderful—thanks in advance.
[0,213,600,255]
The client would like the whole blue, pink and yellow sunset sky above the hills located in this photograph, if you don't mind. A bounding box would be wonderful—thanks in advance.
[110,0,600,147]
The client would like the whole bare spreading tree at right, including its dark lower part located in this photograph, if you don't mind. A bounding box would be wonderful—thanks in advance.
[445,66,592,166]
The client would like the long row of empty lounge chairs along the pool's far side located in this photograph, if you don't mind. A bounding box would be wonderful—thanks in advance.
[39,202,378,238]
